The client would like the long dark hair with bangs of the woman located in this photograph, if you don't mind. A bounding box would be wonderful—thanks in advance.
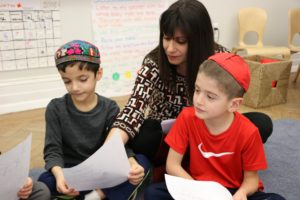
[158,0,215,103]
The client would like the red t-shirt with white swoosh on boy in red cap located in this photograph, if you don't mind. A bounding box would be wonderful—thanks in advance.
[165,107,267,189]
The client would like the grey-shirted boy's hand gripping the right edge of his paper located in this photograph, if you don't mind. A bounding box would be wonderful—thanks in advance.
[128,157,145,185]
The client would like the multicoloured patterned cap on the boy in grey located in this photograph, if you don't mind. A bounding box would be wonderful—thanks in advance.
[55,40,100,65]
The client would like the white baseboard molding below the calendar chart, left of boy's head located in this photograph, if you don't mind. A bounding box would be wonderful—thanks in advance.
[0,74,65,114]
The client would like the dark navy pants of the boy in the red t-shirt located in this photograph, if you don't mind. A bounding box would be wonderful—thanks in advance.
[144,182,285,200]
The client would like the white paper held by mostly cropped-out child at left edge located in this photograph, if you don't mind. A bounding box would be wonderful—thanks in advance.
[0,134,32,200]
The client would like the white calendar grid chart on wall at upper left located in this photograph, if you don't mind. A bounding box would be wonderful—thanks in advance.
[0,0,61,71]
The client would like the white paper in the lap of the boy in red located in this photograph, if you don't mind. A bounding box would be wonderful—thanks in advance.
[165,174,232,200]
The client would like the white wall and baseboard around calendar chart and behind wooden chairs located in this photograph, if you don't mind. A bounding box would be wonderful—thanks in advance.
[0,0,300,114]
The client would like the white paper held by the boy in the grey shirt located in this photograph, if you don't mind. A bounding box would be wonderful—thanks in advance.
[63,134,130,191]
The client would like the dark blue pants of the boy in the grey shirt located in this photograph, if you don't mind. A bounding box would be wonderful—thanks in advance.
[38,154,150,200]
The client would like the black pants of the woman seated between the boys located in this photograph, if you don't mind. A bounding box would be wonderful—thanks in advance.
[129,112,273,161]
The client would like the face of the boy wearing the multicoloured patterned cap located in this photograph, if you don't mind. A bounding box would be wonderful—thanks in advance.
[59,62,102,103]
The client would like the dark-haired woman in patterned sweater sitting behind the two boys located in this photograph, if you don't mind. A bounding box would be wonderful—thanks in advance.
[109,0,272,185]
